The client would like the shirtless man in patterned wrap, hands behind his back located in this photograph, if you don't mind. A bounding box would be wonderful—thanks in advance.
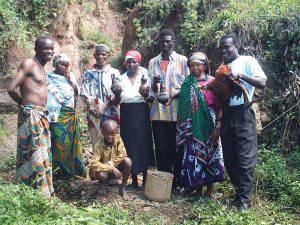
[7,36,54,196]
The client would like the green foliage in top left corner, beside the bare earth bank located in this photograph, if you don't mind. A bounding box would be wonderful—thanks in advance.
[0,0,68,74]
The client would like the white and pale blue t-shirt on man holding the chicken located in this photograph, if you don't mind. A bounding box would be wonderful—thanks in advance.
[229,56,267,106]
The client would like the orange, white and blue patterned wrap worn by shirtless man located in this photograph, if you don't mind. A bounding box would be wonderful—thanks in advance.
[16,104,54,196]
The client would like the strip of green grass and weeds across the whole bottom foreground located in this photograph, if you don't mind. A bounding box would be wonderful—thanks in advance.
[0,178,299,225]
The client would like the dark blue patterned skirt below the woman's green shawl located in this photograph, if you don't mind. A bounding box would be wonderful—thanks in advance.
[179,108,225,190]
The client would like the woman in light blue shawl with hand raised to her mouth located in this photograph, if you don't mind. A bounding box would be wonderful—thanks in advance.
[47,54,85,178]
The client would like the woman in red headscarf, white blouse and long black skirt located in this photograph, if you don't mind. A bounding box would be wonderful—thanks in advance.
[114,50,154,187]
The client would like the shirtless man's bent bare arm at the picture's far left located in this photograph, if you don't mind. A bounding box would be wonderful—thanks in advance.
[7,59,32,104]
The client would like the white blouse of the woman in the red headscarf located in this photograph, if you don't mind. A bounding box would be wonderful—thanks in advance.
[120,66,153,103]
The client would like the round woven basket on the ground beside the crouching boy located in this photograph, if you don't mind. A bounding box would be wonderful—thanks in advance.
[145,170,174,202]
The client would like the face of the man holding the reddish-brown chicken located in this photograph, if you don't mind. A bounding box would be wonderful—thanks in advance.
[219,38,239,63]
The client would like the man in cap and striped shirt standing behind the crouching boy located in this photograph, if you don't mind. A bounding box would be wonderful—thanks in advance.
[81,44,120,149]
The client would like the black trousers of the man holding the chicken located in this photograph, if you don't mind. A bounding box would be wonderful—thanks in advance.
[221,106,258,203]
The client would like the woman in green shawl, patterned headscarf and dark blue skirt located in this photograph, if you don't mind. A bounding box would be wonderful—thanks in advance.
[177,52,224,196]
